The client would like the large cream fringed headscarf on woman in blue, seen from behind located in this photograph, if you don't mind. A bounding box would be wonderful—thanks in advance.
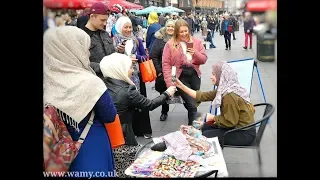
[43,26,107,130]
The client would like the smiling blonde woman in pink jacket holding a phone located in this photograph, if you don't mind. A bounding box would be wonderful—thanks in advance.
[162,19,208,125]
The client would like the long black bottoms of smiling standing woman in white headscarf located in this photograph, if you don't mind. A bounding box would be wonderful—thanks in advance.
[132,73,152,136]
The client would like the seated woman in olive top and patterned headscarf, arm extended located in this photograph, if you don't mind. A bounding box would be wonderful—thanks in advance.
[176,61,256,146]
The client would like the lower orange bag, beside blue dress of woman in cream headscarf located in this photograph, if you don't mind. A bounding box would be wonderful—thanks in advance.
[104,114,125,149]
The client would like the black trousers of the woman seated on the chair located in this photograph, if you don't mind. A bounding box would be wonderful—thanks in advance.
[202,123,256,146]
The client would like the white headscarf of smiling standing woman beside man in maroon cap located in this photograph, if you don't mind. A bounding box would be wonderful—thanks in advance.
[114,16,137,55]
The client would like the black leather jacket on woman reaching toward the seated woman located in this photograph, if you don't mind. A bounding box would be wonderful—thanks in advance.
[104,78,169,146]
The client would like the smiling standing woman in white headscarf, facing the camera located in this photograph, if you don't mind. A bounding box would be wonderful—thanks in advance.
[114,16,152,138]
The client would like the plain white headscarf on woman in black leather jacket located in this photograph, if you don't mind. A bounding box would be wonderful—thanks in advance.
[100,53,134,85]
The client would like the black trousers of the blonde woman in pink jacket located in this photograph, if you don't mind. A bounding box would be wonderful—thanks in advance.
[178,67,201,125]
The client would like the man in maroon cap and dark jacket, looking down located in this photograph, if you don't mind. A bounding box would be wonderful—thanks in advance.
[83,2,116,79]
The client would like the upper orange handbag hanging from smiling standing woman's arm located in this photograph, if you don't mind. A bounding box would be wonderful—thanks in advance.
[139,57,157,83]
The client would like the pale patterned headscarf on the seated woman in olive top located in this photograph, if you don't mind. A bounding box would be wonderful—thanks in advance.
[212,61,250,108]
